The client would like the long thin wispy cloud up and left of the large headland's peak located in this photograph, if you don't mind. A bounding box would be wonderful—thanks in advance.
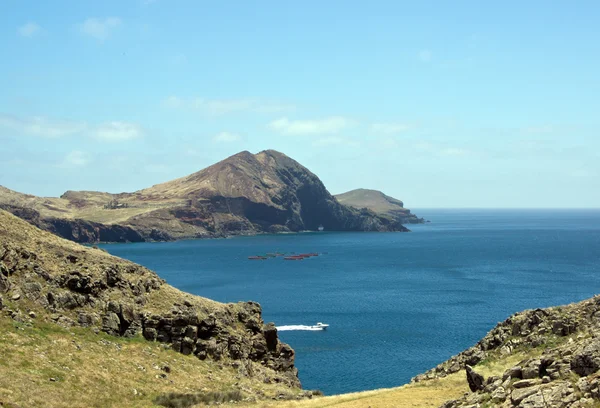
[162,96,296,116]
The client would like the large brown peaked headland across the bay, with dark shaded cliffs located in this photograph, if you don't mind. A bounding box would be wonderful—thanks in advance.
[0,150,407,243]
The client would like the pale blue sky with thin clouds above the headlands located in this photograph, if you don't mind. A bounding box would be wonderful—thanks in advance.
[0,0,600,208]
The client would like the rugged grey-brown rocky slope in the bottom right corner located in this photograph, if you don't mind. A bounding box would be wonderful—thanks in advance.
[412,297,600,408]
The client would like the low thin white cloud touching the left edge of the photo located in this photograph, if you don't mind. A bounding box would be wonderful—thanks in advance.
[0,114,87,138]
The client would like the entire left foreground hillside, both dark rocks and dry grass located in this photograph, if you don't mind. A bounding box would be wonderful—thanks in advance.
[0,210,306,406]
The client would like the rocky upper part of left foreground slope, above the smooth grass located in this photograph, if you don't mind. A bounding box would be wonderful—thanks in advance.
[0,210,310,402]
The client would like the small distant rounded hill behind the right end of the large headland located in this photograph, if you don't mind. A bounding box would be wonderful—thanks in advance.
[335,188,425,224]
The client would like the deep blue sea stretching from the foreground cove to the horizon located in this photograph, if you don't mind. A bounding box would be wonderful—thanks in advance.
[103,210,600,394]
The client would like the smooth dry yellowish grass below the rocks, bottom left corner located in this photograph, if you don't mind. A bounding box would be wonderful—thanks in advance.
[0,317,299,407]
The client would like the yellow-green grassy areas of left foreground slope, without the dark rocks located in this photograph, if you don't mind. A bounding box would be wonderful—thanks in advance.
[0,210,302,407]
